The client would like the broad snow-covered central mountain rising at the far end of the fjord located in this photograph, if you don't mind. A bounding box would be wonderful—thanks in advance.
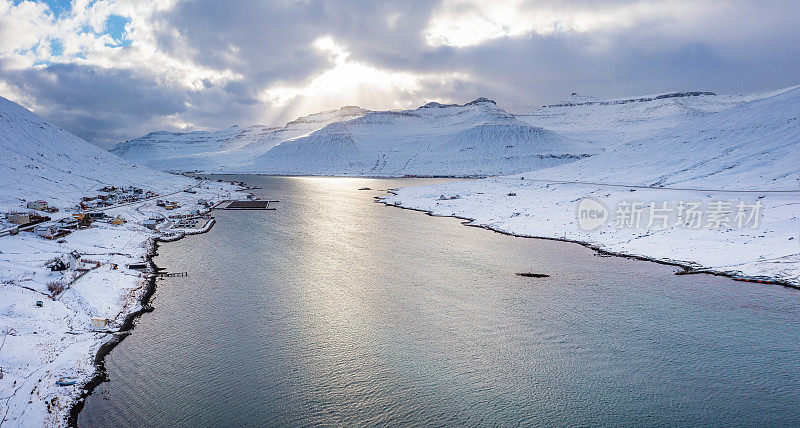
[251,98,597,176]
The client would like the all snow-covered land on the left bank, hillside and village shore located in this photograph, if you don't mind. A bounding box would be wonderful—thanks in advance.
[0,98,245,427]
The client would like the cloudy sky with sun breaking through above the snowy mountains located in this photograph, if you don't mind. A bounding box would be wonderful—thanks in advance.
[0,0,800,147]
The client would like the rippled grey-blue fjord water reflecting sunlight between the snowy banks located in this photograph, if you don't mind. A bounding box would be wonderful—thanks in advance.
[79,176,800,426]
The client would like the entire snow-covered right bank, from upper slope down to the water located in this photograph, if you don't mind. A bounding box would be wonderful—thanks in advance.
[385,87,800,285]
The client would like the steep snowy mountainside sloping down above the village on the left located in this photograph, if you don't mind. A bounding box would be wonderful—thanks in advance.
[0,97,191,211]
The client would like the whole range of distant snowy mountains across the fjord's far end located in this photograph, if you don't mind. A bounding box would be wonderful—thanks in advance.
[112,91,792,176]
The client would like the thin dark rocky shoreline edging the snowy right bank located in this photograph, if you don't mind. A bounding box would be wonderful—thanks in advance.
[382,195,800,290]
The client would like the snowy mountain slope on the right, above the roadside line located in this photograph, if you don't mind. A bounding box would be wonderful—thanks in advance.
[529,87,800,189]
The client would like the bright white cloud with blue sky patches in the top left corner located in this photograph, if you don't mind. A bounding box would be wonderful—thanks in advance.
[0,0,242,90]
